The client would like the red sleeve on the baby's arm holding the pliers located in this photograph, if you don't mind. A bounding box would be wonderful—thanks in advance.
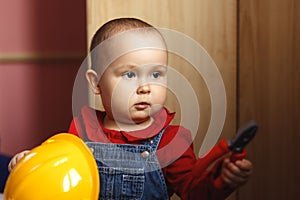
[159,127,233,200]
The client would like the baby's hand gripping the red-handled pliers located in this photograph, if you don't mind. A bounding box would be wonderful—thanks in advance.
[221,158,253,189]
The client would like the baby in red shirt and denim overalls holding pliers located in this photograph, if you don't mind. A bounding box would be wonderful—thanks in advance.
[10,18,252,200]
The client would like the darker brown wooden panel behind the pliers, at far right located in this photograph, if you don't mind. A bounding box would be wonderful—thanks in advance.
[238,0,300,200]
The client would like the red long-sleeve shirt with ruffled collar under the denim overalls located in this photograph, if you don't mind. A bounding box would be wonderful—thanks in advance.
[69,107,232,200]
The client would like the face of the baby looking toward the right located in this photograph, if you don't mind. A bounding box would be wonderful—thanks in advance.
[99,49,167,124]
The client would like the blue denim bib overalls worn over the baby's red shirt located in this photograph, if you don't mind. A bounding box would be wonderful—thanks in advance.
[86,129,169,200]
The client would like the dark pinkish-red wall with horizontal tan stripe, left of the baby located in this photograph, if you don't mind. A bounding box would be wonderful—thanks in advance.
[0,0,86,155]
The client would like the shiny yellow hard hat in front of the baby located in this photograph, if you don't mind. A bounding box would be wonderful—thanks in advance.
[3,133,100,200]
